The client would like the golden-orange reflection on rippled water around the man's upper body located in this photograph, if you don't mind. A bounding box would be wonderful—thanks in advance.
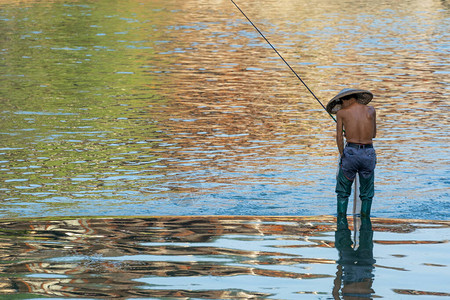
[160,1,449,173]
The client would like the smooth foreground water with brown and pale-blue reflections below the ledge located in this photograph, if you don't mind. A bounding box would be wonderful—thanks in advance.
[0,216,450,299]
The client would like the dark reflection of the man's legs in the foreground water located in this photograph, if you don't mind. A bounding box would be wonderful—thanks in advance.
[333,216,375,299]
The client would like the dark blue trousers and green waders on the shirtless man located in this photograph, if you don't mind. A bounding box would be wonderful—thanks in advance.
[336,146,377,216]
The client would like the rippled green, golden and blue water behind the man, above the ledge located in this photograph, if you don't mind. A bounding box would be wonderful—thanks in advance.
[0,0,450,220]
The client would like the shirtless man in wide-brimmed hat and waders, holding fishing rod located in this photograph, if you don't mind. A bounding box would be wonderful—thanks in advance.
[327,89,377,217]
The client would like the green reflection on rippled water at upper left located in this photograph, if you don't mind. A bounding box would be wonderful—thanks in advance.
[0,1,178,216]
